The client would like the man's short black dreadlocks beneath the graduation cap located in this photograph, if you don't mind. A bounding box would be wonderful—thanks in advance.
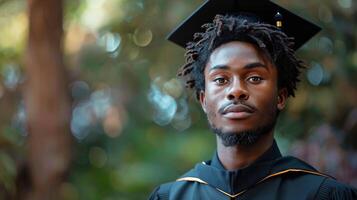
[178,15,305,98]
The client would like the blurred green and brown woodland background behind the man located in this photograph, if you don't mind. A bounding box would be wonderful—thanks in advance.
[0,0,357,200]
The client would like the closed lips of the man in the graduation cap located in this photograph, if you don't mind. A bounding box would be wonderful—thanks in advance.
[222,104,255,119]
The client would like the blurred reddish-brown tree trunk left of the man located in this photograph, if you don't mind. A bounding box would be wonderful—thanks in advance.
[25,0,71,200]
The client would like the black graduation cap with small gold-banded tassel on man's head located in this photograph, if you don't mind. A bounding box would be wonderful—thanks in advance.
[168,0,321,50]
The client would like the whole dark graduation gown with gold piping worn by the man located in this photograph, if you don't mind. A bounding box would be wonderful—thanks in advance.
[149,142,357,200]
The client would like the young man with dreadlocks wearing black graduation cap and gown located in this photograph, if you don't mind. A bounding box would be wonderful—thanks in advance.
[150,0,357,200]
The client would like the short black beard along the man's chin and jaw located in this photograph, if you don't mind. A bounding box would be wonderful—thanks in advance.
[209,112,278,147]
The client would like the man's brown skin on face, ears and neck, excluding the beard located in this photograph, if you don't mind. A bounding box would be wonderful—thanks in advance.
[200,41,287,170]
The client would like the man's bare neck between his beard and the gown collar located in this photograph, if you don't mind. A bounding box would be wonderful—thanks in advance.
[217,133,274,170]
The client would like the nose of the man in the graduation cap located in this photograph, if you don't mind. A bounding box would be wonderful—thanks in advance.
[227,78,249,101]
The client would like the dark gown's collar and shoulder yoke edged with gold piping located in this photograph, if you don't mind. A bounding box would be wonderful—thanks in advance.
[176,141,329,198]
